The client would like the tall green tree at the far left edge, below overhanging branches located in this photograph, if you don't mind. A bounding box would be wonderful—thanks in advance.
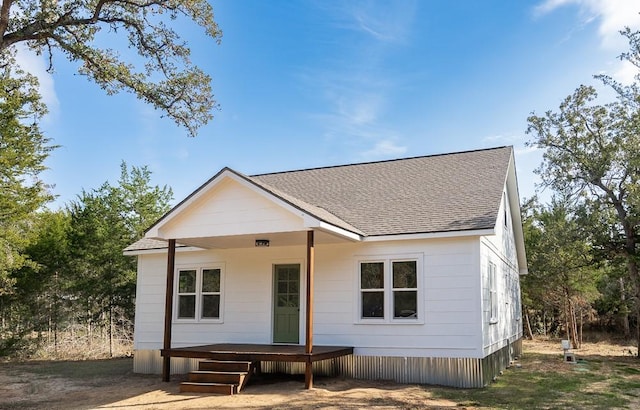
[0,62,55,295]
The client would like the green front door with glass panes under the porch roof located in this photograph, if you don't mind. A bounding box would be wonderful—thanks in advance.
[273,265,300,344]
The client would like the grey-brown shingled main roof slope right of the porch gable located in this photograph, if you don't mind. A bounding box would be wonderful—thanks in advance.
[248,147,512,236]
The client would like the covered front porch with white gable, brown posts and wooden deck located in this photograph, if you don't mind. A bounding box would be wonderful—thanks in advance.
[145,169,362,388]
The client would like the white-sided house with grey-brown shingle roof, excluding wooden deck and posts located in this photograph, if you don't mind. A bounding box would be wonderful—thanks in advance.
[125,147,527,387]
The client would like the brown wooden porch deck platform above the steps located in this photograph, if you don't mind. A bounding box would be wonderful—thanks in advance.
[160,343,353,363]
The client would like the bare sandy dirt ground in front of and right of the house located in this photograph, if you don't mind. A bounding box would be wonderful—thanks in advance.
[0,341,636,409]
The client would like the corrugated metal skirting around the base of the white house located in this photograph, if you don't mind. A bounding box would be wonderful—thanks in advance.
[133,340,522,388]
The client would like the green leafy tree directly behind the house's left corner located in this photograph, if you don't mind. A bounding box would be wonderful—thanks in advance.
[69,163,173,354]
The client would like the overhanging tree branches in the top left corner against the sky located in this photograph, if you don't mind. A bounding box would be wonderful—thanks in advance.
[0,0,222,136]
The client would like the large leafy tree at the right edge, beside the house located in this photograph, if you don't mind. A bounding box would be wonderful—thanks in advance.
[527,30,640,347]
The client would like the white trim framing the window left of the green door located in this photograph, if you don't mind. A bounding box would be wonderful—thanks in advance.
[173,263,225,323]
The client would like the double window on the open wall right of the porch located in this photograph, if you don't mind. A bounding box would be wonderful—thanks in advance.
[357,257,423,323]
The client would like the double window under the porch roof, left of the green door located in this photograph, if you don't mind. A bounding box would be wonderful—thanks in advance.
[176,266,223,321]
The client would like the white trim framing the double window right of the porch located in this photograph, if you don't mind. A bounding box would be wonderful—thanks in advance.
[354,254,426,325]
